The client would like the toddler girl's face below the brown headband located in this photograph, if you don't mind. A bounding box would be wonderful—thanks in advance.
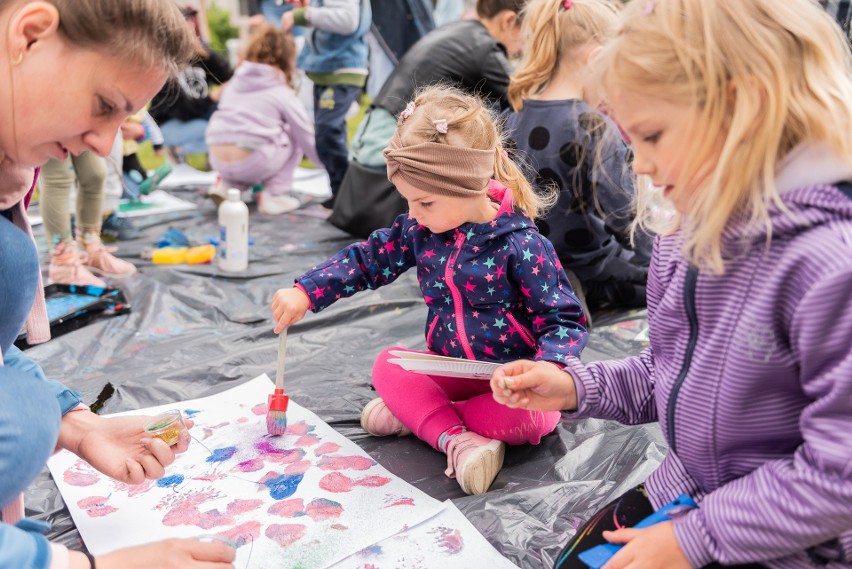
[393,176,497,233]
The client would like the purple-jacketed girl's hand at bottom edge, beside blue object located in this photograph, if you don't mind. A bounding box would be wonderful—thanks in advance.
[602,521,692,569]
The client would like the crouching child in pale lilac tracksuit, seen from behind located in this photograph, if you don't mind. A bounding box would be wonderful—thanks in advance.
[207,24,321,215]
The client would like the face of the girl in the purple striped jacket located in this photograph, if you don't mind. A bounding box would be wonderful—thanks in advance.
[608,89,697,213]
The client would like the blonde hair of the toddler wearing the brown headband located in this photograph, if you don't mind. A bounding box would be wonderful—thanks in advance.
[398,85,558,219]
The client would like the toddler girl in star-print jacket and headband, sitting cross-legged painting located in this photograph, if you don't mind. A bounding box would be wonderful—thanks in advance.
[272,87,587,494]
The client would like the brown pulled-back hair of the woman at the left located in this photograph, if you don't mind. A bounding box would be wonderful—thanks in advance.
[0,0,200,74]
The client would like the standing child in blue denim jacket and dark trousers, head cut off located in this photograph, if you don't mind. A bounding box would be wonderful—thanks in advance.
[281,0,372,208]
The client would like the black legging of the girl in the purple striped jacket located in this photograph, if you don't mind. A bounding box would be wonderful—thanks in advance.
[553,484,765,569]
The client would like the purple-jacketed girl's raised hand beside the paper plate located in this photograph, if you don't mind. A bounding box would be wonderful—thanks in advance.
[491,360,577,411]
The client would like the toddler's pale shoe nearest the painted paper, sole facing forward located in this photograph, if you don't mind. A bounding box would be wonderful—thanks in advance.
[444,431,506,495]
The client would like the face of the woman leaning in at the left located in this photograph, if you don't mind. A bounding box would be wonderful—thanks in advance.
[0,16,167,166]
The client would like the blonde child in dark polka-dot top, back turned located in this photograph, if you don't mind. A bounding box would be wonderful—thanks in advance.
[506,0,651,311]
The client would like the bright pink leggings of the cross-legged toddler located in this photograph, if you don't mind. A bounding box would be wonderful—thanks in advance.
[373,348,559,449]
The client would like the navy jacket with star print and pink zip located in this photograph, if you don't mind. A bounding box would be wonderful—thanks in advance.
[296,181,588,363]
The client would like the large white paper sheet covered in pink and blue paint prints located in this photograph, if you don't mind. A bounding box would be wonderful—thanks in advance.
[48,375,444,569]
